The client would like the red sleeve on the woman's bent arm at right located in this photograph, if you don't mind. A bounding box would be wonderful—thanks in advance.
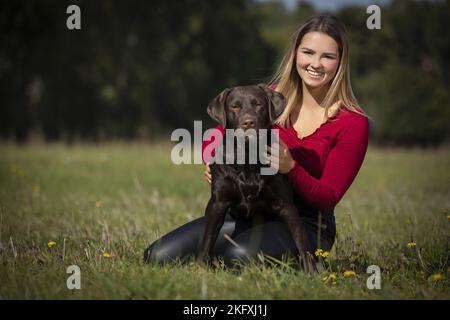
[289,117,369,213]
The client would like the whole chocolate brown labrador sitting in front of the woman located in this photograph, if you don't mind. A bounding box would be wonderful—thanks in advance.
[197,85,315,270]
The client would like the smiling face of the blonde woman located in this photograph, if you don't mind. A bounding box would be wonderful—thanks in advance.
[297,31,340,89]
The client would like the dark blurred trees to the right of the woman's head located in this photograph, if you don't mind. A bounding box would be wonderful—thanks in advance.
[339,0,450,146]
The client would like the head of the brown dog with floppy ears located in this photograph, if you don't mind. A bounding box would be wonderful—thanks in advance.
[207,85,285,131]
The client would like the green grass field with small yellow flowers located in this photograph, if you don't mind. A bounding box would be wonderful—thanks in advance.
[0,143,450,299]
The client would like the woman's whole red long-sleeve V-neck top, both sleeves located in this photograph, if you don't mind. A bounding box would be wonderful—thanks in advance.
[202,109,369,213]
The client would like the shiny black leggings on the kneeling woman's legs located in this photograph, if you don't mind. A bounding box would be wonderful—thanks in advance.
[144,212,336,266]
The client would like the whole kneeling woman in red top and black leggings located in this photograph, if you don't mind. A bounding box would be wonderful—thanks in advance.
[144,15,369,265]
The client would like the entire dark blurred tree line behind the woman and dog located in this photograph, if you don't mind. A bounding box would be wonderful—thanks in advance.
[0,0,450,146]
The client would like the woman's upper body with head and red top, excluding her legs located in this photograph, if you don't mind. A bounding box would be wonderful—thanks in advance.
[272,15,369,215]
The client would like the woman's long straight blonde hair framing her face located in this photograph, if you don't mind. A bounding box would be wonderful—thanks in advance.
[270,15,365,127]
